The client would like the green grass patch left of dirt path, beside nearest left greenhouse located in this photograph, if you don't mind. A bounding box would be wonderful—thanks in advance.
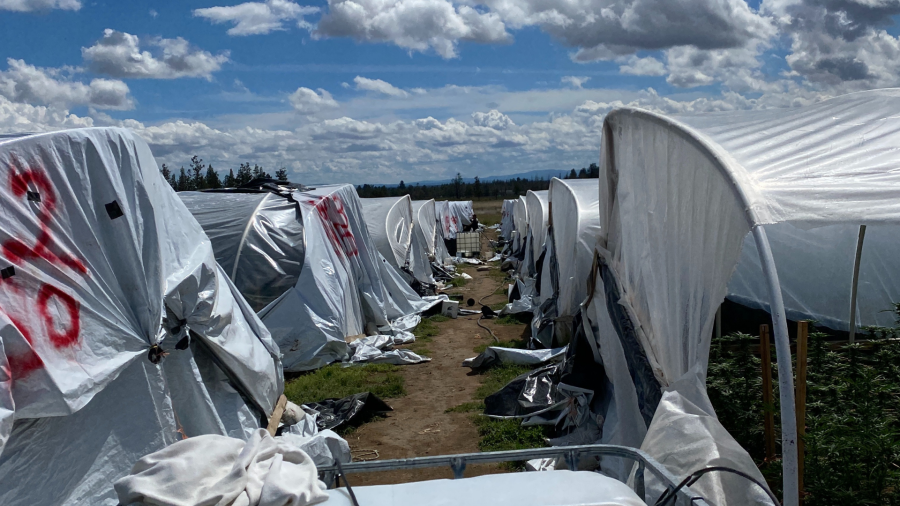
[284,364,406,404]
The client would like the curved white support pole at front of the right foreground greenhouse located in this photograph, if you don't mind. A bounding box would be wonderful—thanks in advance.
[753,225,800,506]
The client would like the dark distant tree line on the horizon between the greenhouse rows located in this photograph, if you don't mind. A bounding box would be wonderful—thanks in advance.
[356,163,600,200]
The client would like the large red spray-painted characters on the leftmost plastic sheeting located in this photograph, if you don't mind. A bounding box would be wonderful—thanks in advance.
[0,162,87,379]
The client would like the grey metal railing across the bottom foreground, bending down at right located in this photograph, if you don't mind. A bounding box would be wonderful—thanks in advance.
[319,445,708,506]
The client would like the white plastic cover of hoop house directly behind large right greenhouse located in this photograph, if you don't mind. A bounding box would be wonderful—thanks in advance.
[541,178,600,324]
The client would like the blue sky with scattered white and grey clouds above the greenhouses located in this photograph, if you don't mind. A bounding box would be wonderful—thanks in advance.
[0,0,900,184]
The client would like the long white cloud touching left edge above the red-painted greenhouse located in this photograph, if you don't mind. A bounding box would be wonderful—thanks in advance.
[0,58,134,109]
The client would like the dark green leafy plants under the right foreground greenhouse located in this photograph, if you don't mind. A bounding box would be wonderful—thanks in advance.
[707,329,900,506]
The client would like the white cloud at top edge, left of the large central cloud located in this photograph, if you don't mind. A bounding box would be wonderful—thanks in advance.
[194,0,319,36]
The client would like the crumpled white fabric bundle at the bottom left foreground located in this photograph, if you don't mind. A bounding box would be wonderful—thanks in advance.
[115,429,328,506]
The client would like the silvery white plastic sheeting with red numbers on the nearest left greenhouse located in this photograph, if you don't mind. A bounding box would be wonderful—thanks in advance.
[0,128,283,505]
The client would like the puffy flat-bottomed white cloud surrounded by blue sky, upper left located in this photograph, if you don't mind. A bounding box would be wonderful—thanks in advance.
[81,28,228,79]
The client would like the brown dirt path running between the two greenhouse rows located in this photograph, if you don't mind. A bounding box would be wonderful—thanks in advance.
[347,229,524,485]
